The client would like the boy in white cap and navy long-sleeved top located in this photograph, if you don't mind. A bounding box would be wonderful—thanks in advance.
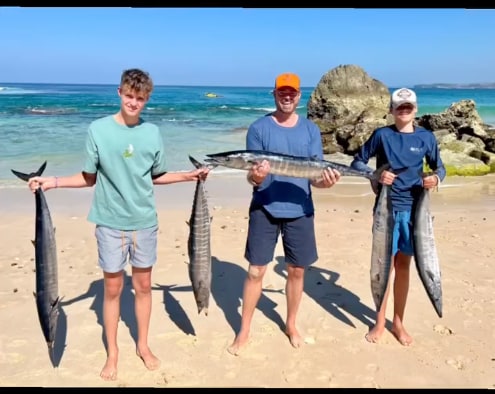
[351,88,446,346]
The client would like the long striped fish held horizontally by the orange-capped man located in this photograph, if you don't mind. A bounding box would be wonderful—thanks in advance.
[205,150,389,180]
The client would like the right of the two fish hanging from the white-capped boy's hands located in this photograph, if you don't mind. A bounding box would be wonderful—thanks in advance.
[413,189,442,317]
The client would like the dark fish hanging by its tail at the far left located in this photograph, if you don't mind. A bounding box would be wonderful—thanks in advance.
[11,161,60,351]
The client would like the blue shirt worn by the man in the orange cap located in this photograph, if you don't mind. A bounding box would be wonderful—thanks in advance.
[246,114,323,219]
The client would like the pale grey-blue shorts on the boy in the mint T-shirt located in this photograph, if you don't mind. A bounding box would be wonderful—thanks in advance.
[95,225,158,273]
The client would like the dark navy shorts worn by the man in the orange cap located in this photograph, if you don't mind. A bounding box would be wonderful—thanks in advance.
[244,207,318,267]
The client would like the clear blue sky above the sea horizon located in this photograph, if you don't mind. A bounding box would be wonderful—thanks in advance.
[0,7,495,87]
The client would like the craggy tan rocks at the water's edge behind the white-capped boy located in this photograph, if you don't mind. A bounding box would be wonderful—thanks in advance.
[307,65,495,174]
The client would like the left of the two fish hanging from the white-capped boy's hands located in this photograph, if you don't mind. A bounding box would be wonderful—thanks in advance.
[370,185,394,311]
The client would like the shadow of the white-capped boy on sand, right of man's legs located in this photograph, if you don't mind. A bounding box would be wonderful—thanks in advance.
[265,256,376,328]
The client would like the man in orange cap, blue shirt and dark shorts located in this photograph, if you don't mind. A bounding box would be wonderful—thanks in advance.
[227,73,340,355]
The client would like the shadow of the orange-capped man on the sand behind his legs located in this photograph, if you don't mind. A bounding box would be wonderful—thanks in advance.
[211,257,285,333]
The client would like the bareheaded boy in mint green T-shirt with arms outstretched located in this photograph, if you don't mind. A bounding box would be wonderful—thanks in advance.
[28,69,209,380]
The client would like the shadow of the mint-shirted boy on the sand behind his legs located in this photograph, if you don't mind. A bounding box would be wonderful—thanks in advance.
[61,271,137,349]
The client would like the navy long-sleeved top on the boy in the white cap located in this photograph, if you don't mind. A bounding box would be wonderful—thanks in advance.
[351,125,445,211]
